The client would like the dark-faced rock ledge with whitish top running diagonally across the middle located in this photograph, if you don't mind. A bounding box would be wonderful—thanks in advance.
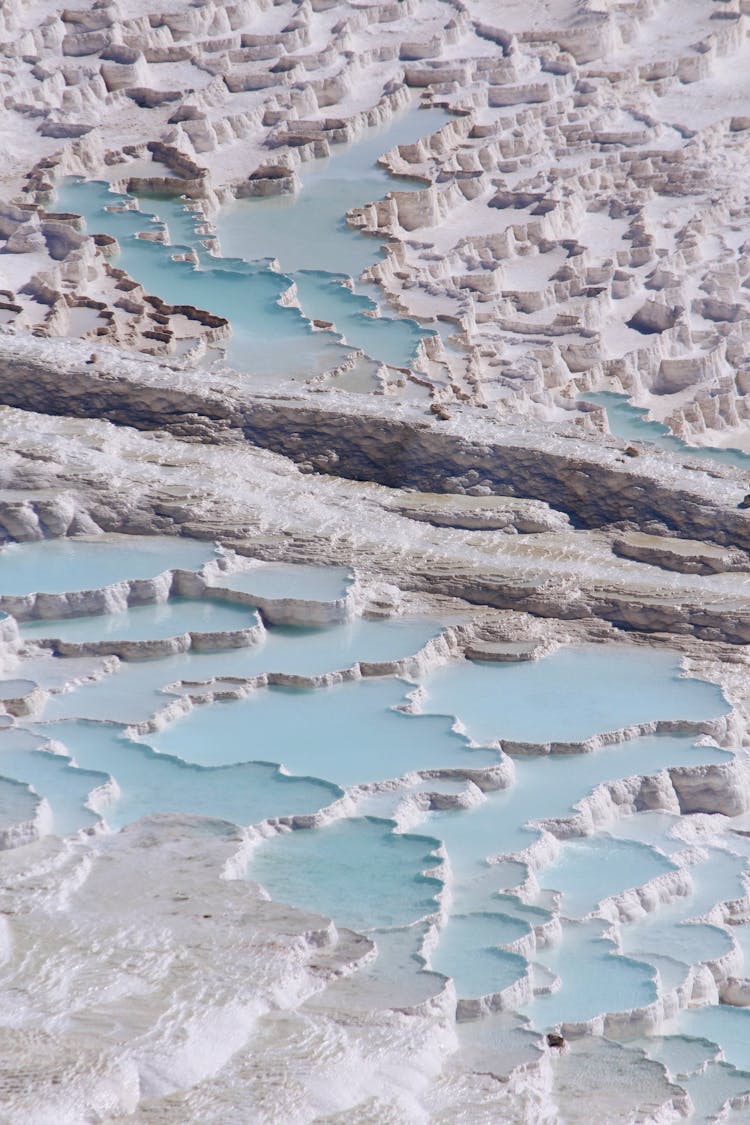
[0,339,750,547]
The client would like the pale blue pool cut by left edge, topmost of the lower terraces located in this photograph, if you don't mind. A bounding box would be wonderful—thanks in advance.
[0,536,215,594]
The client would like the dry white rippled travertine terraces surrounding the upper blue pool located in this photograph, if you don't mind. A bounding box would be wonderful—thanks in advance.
[2,0,750,446]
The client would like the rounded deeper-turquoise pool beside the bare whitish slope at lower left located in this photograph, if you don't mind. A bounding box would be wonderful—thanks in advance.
[247,819,441,932]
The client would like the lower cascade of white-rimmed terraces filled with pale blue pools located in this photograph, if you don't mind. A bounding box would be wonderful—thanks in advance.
[0,536,750,1114]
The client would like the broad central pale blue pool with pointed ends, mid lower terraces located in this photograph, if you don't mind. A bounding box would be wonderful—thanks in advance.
[147,678,497,786]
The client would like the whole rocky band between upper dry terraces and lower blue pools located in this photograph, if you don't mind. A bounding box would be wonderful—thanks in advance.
[0,333,750,644]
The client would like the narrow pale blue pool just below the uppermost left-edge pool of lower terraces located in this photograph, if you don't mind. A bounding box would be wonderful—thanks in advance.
[20,597,260,644]
